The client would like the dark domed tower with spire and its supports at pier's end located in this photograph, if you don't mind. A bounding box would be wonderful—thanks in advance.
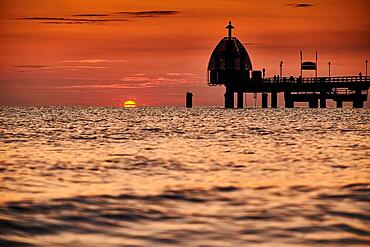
[207,21,252,108]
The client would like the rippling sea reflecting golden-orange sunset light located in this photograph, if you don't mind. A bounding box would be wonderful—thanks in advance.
[0,106,370,247]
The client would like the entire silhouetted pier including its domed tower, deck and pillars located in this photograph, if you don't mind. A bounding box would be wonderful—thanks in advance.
[207,22,370,108]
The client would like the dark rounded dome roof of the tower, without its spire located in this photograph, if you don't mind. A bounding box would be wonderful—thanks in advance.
[208,37,252,71]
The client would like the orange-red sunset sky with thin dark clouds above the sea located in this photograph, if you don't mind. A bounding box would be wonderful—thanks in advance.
[0,0,370,106]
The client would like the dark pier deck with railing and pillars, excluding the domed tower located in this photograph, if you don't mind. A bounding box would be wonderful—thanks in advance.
[217,76,370,108]
